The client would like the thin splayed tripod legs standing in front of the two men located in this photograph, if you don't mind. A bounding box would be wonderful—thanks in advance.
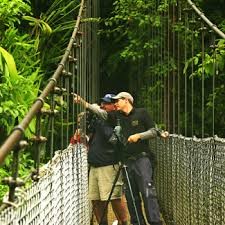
[99,162,141,225]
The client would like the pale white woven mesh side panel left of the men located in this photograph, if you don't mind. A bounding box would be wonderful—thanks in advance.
[0,144,90,225]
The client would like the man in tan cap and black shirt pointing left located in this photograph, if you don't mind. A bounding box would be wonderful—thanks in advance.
[74,92,168,225]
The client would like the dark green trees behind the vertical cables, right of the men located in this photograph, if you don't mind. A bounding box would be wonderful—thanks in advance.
[100,0,225,137]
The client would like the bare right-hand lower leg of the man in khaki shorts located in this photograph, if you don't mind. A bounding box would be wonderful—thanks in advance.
[111,197,128,225]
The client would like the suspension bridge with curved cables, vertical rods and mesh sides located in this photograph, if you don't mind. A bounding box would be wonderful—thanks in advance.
[0,0,225,225]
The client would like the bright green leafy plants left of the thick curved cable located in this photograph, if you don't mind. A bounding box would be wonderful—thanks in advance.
[0,0,79,198]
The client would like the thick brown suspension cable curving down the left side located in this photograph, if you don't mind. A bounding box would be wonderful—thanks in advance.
[0,0,84,164]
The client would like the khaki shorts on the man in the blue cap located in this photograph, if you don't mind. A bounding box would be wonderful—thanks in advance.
[89,165,123,201]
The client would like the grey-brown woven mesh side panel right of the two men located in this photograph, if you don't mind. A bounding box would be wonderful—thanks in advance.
[151,135,225,225]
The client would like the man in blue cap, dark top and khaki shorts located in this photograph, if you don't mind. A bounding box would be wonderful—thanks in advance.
[88,94,127,225]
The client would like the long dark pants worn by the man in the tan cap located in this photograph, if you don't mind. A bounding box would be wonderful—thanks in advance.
[124,156,161,225]
